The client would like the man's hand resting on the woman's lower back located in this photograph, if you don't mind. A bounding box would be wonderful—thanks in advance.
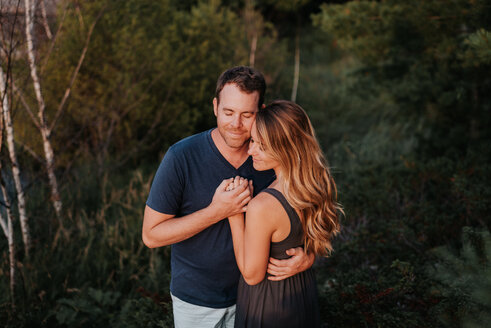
[268,247,315,281]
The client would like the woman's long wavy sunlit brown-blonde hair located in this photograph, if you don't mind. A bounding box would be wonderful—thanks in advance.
[256,100,344,256]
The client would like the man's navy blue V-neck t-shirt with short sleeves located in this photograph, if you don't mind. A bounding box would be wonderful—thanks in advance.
[147,130,274,308]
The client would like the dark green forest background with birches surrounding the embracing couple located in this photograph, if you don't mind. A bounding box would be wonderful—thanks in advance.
[0,0,491,328]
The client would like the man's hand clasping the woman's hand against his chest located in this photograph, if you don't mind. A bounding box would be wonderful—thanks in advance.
[210,177,252,220]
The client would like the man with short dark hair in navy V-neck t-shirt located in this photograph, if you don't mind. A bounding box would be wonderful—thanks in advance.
[142,66,314,328]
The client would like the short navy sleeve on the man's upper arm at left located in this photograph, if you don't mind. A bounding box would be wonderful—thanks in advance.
[146,147,184,215]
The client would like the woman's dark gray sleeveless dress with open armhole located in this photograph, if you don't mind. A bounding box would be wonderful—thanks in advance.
[235,188,320,328]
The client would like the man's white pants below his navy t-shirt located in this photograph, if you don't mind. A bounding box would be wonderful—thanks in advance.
[171,294,235,328]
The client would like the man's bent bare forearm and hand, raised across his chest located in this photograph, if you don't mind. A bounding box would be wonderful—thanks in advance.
[142,179,251,248]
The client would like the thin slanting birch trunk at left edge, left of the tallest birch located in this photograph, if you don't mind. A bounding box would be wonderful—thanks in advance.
[0,67,31,256]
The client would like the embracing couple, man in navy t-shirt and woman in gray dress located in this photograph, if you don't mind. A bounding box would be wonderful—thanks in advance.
[142,66,342,328]
